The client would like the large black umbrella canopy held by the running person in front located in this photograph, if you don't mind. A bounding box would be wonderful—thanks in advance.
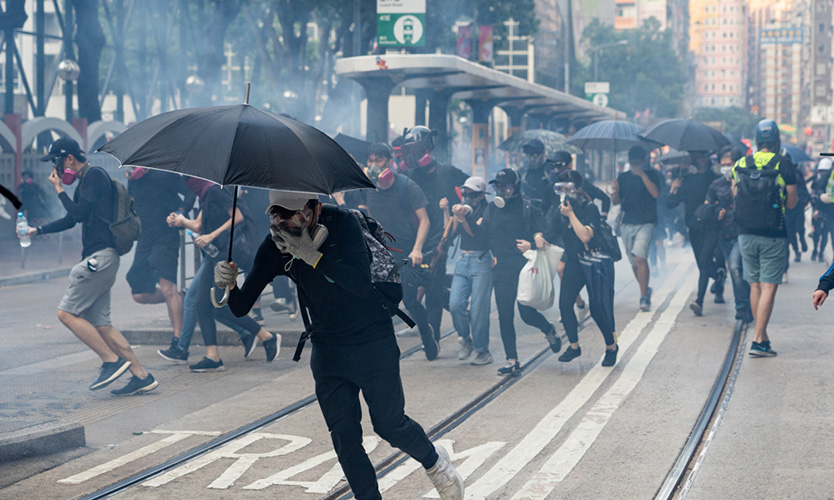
[99,104,375,194]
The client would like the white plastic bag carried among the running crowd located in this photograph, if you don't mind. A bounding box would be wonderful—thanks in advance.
[516,245,564,311]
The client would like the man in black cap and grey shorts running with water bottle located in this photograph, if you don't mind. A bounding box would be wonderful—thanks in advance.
[27,137,159,396]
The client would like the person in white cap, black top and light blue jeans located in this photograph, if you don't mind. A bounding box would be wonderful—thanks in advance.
[449,176,492,366]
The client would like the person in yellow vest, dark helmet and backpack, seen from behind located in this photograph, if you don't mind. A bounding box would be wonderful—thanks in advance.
[733,120,797,357]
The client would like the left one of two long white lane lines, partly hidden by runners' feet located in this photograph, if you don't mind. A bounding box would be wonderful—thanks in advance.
[466,262,690,500]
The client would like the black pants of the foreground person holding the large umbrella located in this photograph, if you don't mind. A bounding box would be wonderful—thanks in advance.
[310,331,437,500]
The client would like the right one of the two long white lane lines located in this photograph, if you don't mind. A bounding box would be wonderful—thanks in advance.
[512,273,698,500]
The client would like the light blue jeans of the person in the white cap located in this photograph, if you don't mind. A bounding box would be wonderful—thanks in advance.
[449,250,492,352]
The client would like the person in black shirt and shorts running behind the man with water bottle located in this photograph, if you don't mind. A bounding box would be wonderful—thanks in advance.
[127,167,196,352]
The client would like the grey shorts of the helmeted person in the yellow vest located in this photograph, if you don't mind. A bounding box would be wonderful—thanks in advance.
[738,234,788,285]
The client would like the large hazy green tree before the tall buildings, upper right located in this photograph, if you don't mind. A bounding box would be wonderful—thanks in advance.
[582,18,689,117]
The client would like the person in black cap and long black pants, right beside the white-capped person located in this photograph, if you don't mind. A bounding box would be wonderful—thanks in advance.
[475,168,562,375]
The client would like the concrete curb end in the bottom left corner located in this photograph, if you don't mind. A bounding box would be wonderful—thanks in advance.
[0,422,87,462]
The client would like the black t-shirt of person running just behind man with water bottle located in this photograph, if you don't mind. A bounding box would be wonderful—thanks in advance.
[127,170,194,245]
